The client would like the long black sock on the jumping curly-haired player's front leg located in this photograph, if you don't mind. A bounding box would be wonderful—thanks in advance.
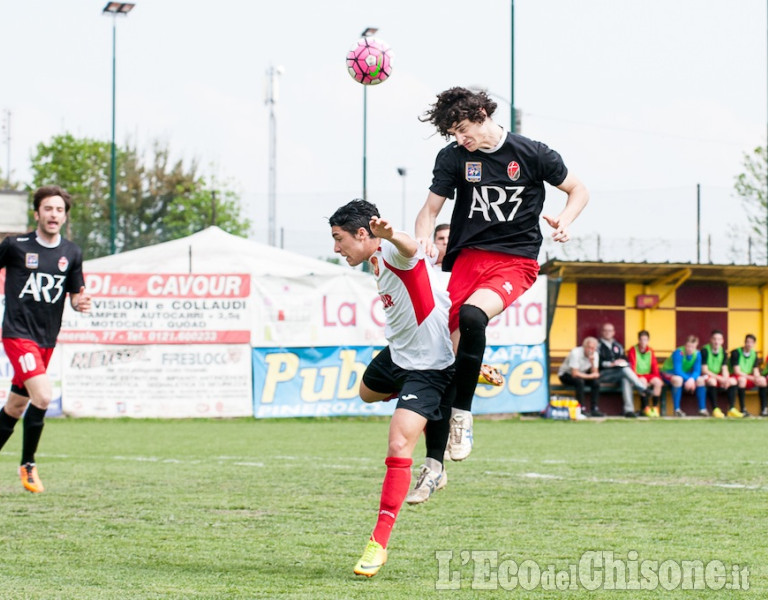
[453,304,488,411]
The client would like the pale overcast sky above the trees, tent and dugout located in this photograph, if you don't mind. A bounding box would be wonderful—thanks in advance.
[0,0,768,262]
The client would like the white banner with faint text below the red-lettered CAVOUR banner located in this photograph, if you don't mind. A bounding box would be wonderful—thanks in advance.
[60,344,253,418]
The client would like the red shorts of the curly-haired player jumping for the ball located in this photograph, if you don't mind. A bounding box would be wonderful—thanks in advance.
[448,248,539,332]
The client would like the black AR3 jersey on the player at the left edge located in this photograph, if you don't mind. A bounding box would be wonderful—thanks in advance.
[0,231,84,348]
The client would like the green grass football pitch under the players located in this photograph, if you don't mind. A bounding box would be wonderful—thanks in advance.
[0,419,768,600]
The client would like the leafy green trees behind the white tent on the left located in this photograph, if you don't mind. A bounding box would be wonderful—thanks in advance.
[32,133,250,258]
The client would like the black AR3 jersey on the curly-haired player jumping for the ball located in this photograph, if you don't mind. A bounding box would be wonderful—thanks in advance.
[429,131,568,271]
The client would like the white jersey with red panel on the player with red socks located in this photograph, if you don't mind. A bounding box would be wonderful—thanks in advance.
[369,240,454,371]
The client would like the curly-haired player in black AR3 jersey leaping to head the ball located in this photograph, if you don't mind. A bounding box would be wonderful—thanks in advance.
[416,87,589,460]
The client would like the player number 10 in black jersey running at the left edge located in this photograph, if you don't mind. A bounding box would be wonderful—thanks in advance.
[0,186,91,493]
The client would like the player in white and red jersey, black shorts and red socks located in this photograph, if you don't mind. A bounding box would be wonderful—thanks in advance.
[328,200,454,577]
